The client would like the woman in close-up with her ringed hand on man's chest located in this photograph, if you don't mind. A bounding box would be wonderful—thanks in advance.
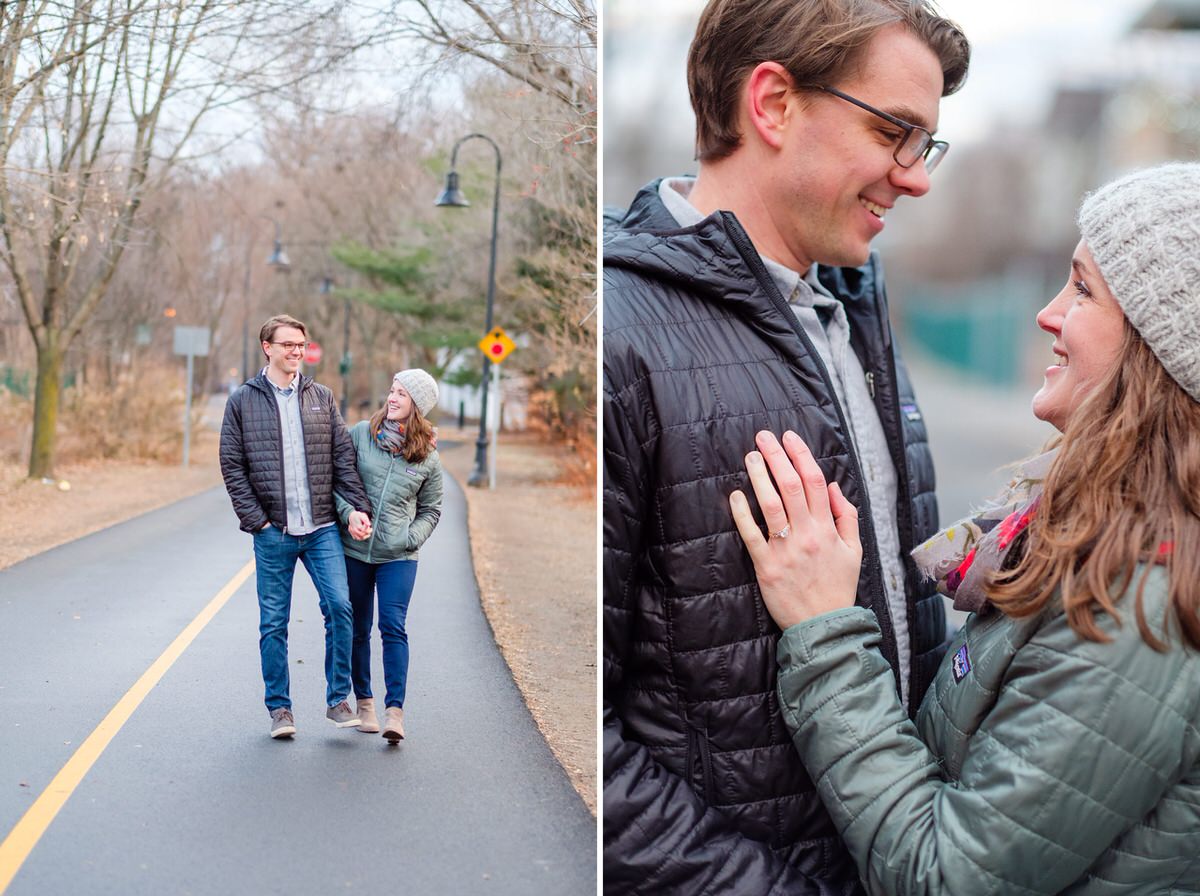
[730,164,1200,896]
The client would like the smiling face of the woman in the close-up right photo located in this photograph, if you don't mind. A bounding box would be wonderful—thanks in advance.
[1033,240,1126,432]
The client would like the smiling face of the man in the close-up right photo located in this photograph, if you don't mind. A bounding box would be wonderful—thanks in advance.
[769,25,942,265]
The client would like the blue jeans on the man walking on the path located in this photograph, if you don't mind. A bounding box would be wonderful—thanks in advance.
[254,525,354,710]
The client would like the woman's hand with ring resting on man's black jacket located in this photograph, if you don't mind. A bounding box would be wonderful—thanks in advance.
[730,431,863,629]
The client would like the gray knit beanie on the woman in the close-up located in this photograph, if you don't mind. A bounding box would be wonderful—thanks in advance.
[1079,162,1200,401]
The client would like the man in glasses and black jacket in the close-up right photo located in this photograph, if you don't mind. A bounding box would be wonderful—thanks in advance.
[604,0,970,896]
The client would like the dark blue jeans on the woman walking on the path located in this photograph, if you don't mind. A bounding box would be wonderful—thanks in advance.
[346,557,416,706]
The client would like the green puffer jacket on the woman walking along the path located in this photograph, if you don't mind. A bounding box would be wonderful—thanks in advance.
[335,420,442,563]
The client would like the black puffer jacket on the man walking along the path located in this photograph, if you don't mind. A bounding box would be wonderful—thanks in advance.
[221,373,371,533]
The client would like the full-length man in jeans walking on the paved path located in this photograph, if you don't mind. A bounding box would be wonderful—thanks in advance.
[221,314,371,738]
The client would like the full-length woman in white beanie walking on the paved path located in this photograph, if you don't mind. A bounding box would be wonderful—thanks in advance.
[338,368,442,744]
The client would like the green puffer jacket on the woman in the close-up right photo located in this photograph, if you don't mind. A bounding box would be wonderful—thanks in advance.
[778,567,1200,896]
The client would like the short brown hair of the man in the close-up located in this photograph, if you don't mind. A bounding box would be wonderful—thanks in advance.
[688,0,971,162]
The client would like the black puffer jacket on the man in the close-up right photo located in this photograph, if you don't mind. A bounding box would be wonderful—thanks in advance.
[604,184,944,896]
